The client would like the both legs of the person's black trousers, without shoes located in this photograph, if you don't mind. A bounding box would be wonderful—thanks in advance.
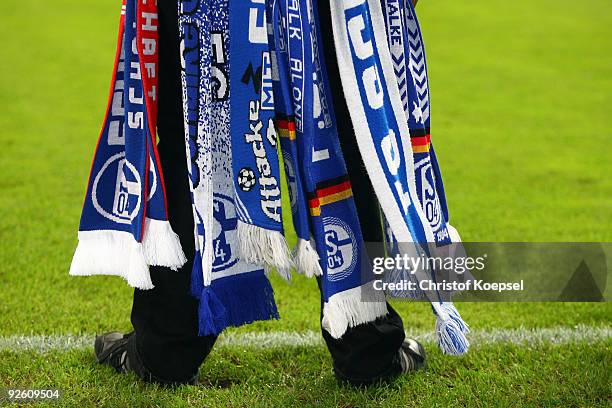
[128,0,404,384]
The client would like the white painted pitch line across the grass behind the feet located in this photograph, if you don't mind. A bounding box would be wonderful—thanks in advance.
[0,325,612,353]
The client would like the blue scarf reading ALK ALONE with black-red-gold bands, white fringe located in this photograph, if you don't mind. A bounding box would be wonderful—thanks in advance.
[269,0,387,338]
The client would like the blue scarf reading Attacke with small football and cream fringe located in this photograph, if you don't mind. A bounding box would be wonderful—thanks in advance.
[230,1,293,279]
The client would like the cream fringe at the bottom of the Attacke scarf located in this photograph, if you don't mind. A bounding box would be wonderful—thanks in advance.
[238,220,295,280]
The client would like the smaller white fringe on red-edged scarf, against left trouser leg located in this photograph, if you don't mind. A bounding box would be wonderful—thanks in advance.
[143,218,187,271]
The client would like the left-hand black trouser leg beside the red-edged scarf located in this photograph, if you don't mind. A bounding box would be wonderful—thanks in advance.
[130,0,216,383]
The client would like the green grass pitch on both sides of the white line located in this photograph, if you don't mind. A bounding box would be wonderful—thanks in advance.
[0,0,612,407]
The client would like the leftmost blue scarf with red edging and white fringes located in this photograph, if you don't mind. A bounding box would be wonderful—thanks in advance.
[70,0,186,289]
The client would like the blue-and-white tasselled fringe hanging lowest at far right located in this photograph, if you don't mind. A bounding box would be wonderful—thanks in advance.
[432,302,470,356]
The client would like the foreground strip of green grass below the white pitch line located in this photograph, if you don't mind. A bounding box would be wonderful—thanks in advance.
[0,342,612,408]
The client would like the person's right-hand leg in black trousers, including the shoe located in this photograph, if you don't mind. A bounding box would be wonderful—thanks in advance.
[318,0,424,385]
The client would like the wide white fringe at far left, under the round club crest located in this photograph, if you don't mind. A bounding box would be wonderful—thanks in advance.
[70,231,153,290]
